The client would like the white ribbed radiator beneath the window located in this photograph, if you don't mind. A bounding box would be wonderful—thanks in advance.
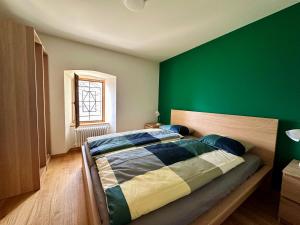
[75,123,110,147]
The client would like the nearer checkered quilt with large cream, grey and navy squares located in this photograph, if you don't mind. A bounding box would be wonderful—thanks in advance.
[90,132,244,225]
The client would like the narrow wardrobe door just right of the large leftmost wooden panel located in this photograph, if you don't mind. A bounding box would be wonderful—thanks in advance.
[35,43,47,167]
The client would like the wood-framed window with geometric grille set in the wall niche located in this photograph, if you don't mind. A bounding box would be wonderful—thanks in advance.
[75,75,105,127]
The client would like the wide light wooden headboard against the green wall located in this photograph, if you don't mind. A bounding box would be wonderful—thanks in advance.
[171,109,278,166]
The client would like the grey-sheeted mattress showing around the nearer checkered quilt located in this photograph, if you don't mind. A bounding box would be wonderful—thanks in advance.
[90,140,261,225]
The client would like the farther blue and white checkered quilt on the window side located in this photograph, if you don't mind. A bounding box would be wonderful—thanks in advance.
[88,129,183,156]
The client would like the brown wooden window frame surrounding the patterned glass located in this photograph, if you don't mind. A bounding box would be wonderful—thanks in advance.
[74,74,105,127]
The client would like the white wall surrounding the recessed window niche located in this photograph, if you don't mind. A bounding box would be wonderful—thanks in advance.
[39,34,159,154]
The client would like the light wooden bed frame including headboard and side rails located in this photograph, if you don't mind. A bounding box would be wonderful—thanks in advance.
[82,110,278,225]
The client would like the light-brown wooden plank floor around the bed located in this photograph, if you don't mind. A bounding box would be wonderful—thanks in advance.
[0,152,278,225]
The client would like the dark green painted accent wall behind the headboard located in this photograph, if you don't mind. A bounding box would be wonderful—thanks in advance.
[159,3,300,187]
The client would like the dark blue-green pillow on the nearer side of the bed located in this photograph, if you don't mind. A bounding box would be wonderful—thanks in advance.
[200,134,250,156]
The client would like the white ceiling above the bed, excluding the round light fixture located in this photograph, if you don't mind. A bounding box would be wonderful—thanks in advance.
[0,0,299,61]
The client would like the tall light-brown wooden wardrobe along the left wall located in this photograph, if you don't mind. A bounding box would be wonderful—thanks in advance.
[0,20,51,199]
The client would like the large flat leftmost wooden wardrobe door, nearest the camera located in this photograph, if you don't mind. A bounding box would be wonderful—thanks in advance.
[0,20,40,199]
